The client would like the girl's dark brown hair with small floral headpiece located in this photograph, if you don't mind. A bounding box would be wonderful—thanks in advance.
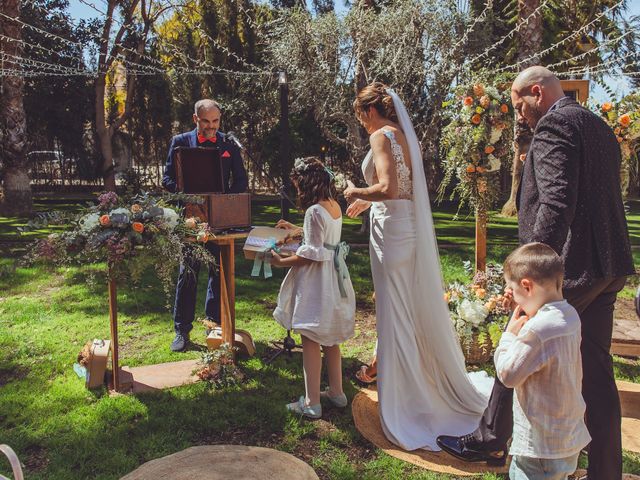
[290,157,338,210]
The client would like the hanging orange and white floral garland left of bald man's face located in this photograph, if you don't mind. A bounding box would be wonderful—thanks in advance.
[439,75,513,211]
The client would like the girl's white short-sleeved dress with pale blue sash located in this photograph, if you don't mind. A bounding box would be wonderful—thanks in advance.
[273,204,356,347]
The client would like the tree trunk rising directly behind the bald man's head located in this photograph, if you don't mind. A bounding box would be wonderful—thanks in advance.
[502,0,544,217]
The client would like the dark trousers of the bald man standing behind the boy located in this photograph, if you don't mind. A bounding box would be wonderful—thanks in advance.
[473,277,626,480]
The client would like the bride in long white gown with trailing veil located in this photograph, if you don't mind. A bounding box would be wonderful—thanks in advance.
[344,82,491,450]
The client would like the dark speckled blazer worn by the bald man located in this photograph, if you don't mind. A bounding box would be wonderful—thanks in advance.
[517,97,634,289]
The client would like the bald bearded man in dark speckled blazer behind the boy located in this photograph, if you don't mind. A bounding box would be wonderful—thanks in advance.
[438,66,635,480]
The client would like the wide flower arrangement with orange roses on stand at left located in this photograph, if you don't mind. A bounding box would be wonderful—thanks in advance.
[27,192,214,297]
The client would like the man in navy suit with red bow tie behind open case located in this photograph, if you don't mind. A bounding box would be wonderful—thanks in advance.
[162,99,248,352]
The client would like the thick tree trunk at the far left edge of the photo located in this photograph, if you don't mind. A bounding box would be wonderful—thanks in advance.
[0,0,33,216]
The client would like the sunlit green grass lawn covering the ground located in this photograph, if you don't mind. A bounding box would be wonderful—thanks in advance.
[0,197,640,480]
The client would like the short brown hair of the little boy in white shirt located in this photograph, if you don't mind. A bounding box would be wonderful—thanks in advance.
[504,242,564,283]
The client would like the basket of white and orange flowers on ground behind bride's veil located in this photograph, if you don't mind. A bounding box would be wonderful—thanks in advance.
[444,262,509,365]
